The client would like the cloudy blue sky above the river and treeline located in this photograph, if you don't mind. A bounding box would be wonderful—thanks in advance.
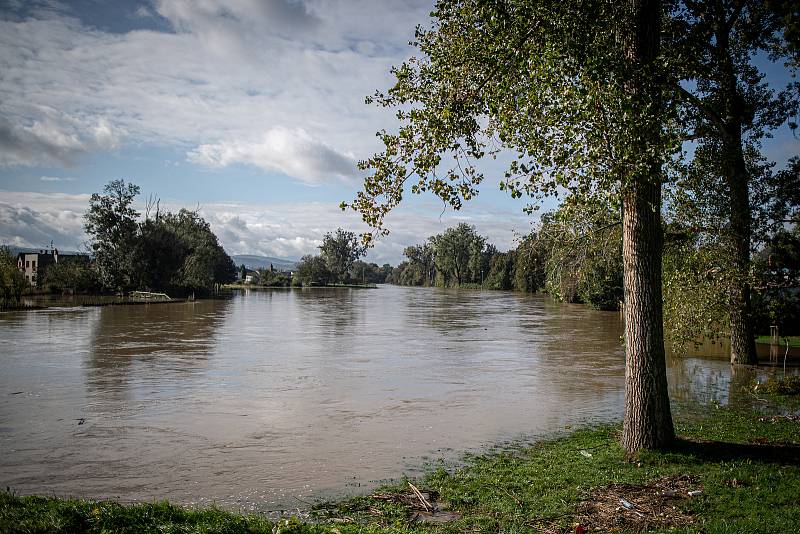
[0,0,797,264]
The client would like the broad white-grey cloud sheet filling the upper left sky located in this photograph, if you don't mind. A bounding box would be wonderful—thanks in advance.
[0,0,430,183]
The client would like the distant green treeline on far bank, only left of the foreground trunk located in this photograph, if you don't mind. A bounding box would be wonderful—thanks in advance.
[388,209,622,310]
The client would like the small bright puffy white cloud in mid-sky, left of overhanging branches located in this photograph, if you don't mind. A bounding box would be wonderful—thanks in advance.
[189,128,356,184]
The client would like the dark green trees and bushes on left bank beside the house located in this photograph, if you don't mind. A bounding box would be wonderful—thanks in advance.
[0,180,236,308]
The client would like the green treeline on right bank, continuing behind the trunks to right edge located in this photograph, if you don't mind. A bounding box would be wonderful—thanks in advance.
[387,200,800,344]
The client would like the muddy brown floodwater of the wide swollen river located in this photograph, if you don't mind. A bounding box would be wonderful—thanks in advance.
[0,286,796,510]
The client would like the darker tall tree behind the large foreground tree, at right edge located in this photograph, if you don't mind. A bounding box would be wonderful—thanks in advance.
[664,0,800,364]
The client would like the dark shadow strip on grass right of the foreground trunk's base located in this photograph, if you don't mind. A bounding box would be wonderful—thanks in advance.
[670,438,800,465]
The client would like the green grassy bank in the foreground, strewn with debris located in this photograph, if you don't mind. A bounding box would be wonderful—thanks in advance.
[0,408,800,534]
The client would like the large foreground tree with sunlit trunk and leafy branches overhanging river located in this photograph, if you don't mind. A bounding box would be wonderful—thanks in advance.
[342,0,679,451]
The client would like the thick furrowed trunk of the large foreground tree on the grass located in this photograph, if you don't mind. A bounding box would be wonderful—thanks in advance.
[621,0,675,452]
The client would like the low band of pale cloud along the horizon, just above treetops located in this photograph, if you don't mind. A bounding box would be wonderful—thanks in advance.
[0,190,531,265]
